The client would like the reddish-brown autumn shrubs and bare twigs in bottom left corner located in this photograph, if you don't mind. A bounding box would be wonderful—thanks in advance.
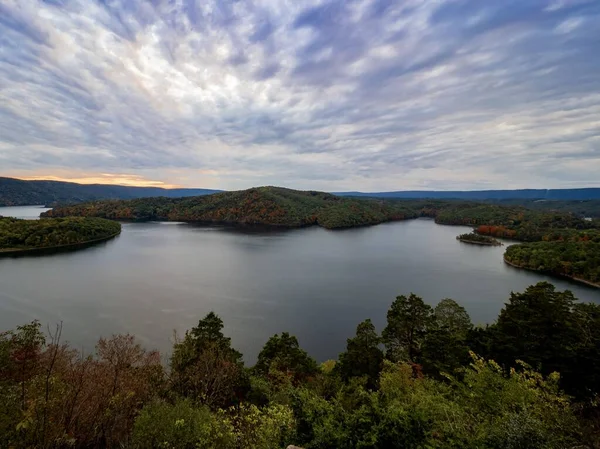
[0,322,163,448]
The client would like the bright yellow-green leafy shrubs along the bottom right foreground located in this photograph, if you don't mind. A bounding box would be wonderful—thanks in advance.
[293,357,581,449]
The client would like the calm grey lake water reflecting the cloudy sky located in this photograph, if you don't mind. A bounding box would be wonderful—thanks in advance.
[0,207,600,363]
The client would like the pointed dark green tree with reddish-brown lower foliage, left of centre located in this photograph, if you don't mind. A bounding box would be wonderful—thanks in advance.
[171,312,249,408]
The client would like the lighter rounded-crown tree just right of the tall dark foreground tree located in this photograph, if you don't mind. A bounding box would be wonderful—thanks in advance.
[422,299,473,375]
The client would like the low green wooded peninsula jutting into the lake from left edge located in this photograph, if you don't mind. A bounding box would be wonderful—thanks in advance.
[0,217,121,252]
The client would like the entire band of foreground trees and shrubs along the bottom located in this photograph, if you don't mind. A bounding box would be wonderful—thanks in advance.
[0,283,600,449]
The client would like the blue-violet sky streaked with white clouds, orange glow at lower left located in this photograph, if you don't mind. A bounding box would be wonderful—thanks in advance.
[0,0,600,191]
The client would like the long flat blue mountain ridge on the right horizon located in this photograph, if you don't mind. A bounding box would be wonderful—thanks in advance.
[334,187,600,200]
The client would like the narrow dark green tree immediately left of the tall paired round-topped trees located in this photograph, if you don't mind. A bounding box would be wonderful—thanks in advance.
[334,319,383,389]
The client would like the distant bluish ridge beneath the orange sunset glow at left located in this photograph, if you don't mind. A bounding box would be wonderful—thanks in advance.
[0,178,218,207]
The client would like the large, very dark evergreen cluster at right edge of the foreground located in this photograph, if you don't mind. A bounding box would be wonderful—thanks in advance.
[487,282,600,397]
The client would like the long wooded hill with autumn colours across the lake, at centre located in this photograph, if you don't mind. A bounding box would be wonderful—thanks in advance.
[44,187,416,229]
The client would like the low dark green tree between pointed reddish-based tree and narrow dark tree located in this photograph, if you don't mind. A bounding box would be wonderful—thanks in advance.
[254,332,318,381]
